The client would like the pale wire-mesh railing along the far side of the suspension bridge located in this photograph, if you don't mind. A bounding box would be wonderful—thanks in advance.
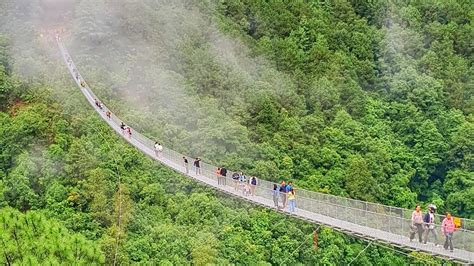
[58,38,474,252]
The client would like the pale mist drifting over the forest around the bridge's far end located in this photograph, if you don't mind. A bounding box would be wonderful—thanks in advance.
[0,0,295,163]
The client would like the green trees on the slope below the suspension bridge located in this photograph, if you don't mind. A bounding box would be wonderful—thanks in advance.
[0,61,444,265]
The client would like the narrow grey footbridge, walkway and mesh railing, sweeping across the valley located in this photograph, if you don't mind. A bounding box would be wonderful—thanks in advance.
[57,37,474,263]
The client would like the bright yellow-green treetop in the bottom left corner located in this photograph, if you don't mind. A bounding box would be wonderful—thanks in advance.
[0,208,105,265]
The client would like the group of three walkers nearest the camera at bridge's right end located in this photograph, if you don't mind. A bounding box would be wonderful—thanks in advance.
[410,204,458,252]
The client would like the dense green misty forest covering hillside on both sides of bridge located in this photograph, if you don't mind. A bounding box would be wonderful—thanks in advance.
[0,0,474,265]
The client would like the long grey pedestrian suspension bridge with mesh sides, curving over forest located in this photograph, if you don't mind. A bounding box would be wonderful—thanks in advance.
[56,35,474,264]
